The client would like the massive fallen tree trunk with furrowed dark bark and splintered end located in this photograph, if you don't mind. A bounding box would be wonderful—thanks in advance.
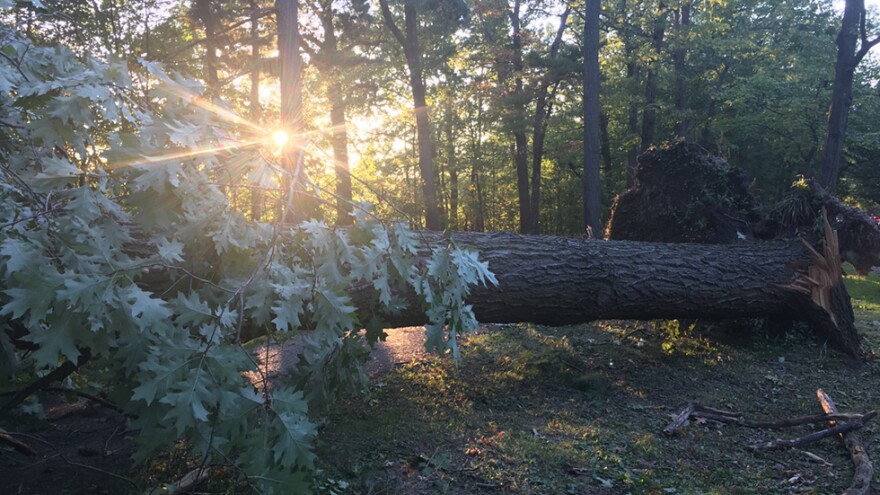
[372,223,860,356]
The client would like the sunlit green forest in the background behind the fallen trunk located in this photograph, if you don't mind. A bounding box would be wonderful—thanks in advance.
[5,0,880,235]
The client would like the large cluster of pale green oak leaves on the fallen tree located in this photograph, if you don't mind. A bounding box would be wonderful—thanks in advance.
[0,13,495,493]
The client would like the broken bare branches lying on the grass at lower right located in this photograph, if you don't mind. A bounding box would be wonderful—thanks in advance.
[663,394,877,495]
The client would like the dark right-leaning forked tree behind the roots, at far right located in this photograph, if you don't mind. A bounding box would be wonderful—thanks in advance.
[819,0,880,191]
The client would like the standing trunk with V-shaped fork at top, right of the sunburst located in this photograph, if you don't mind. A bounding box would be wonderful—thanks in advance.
[379,0,442,230]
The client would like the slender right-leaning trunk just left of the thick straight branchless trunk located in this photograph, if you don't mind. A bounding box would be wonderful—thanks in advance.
[529,7,571,234]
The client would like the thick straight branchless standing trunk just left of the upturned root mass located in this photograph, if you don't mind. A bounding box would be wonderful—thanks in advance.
[582,0,602,238]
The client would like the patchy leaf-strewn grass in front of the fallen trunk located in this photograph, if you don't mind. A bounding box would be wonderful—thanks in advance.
[317,275,880,494]
